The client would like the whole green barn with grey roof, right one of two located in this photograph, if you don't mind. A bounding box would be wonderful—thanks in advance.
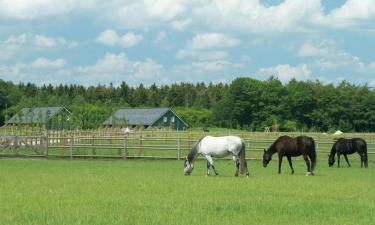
[103,108,188,130]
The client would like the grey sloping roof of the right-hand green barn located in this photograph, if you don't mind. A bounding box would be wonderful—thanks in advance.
[103,108,181,126]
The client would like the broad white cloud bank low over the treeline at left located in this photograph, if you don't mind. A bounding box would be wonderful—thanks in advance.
[0,53,167,86]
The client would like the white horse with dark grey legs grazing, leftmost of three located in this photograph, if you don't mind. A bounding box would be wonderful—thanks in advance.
[184,136,249,177]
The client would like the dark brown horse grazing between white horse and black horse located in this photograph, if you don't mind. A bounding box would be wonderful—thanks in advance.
[263,136,316,176]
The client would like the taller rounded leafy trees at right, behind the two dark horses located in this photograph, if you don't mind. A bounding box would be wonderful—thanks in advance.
[214,78,375,131]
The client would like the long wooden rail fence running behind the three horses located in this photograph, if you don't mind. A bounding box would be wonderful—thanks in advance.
[0,133,375,160]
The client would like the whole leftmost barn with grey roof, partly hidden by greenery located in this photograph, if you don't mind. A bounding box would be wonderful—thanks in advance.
[6,107,71,130]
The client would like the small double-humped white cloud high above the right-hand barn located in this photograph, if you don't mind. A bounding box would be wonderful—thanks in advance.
[96,29,143,48]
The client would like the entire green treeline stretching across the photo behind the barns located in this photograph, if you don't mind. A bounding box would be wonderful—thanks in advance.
[0,77,375,131]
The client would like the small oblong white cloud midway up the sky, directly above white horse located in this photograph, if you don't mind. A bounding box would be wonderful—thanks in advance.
[191,33,240,49]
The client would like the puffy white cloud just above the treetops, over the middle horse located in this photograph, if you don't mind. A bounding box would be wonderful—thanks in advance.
[257,64,311,82]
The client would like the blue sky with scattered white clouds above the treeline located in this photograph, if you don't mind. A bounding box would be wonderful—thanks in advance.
[0,0,375,86]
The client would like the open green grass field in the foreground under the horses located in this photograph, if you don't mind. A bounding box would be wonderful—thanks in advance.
[0,156,375,225]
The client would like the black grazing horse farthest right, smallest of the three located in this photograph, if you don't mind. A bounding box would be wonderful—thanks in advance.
[328,138,368,168]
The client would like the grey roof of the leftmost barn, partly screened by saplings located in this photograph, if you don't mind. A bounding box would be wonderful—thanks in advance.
[6,107,70,124]
